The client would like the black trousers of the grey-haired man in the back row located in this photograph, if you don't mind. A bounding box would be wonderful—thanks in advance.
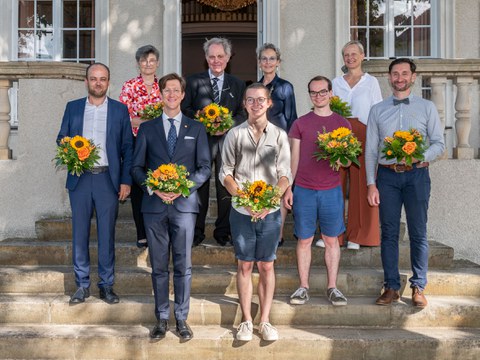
[195,135,232,243]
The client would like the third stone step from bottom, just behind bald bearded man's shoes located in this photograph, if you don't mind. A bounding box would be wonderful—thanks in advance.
[0,262,480,297]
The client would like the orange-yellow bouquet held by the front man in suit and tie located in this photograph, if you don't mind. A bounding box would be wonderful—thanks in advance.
[144,164,195,204]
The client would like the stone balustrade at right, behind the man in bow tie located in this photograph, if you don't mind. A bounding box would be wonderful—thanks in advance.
[364,59,480,159]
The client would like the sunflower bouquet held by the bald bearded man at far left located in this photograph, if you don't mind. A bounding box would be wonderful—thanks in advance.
[54,135,100,176]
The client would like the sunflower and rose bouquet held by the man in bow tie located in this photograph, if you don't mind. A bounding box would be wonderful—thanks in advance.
[382,128,426,166]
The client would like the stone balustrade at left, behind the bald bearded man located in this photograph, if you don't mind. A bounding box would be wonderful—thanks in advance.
[0,61,86,160]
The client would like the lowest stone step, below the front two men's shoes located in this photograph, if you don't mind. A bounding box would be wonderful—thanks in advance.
[0,324,480,360]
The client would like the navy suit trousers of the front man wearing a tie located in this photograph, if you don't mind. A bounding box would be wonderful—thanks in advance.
[143,208,197,320]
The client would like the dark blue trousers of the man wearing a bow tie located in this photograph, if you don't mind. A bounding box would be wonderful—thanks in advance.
[377,166,430,290]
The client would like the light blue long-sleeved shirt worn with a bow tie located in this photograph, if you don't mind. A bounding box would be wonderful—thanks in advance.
[365,94,445,185]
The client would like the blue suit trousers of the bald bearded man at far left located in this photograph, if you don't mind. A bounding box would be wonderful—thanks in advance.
[69,171,118,288]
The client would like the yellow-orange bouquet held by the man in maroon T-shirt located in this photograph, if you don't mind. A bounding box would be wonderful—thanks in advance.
[313,127,362,171]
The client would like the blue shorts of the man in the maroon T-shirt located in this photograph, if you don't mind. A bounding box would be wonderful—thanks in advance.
[293,185,345,239]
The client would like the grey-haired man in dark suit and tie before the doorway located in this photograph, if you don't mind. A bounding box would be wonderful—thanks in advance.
[182,37,246,246]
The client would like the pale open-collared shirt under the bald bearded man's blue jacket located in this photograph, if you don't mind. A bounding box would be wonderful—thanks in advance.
[83,97,108,166]
